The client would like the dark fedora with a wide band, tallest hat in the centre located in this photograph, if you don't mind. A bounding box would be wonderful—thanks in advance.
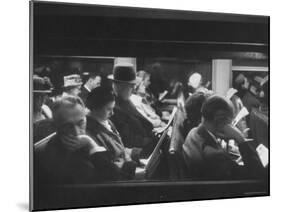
[107,63,138,84]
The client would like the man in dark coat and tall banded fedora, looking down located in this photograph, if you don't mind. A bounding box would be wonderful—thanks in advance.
[108,63,156,157]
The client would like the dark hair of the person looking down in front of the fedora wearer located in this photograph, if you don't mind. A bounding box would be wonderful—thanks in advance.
[86,87,115,110]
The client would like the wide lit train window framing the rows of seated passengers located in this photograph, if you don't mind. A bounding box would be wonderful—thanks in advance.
[33,56,267,183]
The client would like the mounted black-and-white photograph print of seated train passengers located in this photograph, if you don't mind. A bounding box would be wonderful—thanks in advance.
[30,1,270,210]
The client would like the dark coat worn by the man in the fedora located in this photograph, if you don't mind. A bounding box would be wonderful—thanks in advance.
[111,98,156,157]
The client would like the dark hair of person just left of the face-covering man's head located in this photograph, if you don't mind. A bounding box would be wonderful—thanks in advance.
[185,92,206,125]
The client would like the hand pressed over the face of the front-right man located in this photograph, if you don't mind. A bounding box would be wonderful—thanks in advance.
[216,124,245,144]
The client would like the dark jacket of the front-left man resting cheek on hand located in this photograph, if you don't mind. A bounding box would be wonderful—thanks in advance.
[34,135,120,185]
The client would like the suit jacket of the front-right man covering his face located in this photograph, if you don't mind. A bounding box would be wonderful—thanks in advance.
[180,125,264,179]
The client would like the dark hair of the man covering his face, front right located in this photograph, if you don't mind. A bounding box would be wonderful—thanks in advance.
[202,95,234,121]
